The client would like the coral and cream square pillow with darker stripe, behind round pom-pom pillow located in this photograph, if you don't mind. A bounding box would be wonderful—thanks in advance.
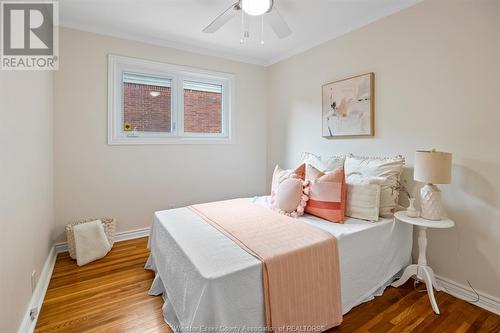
[305,164,347,223]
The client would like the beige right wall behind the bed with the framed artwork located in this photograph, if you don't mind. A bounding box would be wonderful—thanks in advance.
[268,0,500,297]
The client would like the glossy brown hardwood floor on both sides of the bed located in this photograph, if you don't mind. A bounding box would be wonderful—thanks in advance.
[35,238,500,333]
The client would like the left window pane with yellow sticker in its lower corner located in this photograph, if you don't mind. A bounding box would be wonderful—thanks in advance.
[122,73,172,132]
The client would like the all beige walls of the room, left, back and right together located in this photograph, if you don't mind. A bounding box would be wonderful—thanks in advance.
[0,0,500,332]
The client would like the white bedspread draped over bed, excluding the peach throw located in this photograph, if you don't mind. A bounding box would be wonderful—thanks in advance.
[146,197,412,332]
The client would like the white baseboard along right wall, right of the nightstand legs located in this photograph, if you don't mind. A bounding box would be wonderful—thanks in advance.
[436,275,500,315]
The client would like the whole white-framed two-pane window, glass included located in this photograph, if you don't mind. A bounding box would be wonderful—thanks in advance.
[108,55,233,144]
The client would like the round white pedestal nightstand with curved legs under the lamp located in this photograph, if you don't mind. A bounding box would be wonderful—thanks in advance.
[392,211,455,314]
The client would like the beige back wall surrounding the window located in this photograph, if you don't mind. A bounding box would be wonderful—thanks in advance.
[54,29,267,241]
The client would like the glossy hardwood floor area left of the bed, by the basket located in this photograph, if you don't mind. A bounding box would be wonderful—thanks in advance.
[35,238,171,332]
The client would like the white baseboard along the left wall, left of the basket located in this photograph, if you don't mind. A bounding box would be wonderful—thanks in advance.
[18,246,57,333]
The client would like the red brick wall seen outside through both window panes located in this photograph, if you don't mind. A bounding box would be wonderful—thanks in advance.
[123,82,222,133]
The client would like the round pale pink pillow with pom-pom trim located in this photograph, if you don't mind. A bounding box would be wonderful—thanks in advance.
[271,173,309,217]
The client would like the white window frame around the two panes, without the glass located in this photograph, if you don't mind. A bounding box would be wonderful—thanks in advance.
[108,54,234,145]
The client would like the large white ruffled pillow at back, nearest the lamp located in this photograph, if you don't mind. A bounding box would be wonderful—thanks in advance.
[344,156,404,217]
